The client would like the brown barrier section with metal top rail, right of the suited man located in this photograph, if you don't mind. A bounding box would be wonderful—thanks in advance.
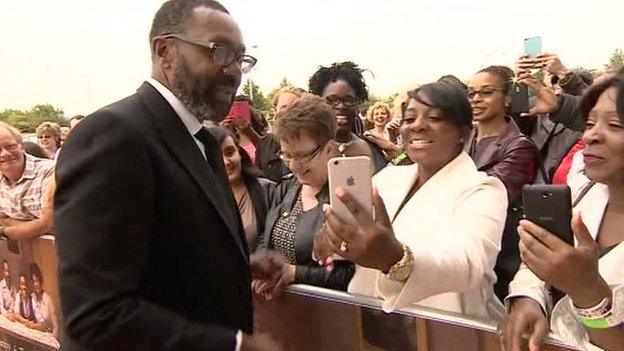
[254,285,575,351]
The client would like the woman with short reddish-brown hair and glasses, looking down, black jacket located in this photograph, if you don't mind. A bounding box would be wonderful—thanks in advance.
[253,94,354,294]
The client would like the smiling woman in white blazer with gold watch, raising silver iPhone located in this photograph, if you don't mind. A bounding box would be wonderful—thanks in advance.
[316,83,507,320]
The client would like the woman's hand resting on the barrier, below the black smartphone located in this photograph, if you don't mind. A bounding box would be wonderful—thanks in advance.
[500,297,548,351]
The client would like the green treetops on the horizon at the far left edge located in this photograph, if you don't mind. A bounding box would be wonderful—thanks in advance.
[0,104,68,133]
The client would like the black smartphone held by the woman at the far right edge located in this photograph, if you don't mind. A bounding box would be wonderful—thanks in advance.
[522,184,574,246]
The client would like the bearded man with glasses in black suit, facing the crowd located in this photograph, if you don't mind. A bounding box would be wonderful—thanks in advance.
[54,0,283,351]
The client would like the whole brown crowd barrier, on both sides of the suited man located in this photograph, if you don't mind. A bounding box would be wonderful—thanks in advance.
[0,236,574,351]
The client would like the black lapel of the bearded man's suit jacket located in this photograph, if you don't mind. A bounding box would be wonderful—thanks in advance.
[138,82,248,260]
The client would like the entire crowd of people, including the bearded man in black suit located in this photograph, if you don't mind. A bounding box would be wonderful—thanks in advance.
[0,0,624,350]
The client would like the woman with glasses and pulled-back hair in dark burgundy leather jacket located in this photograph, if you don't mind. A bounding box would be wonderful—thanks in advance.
[464,66,537,300]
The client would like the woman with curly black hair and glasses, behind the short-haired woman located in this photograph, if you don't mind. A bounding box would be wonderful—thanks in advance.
[309,62,388,173]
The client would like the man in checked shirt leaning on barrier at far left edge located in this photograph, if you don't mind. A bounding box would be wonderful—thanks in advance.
[0,122,54,240]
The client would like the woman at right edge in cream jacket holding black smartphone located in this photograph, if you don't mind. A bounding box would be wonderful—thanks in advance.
[503,76,624,350]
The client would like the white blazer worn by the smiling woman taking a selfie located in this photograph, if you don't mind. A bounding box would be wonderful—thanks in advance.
[349,152,507,320]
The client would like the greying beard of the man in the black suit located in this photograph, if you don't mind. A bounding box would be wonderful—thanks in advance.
[171,56,238,123]
